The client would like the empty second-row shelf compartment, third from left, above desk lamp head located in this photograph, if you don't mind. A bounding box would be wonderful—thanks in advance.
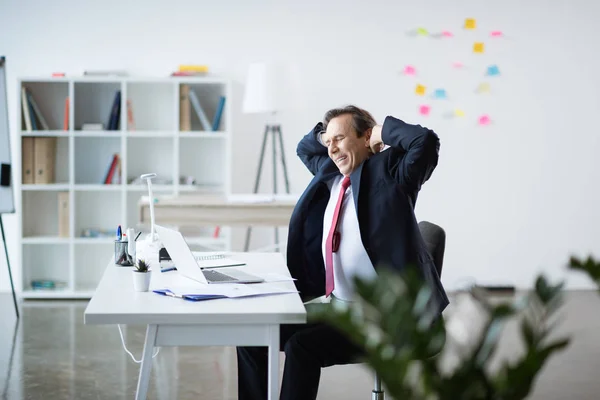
[127,136,175,187]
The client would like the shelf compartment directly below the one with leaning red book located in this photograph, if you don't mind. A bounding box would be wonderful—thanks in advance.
[74,191,123,238]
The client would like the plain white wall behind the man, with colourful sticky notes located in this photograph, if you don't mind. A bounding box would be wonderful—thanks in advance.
[0,0,600,290]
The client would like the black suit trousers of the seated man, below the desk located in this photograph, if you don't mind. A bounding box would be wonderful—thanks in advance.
[237,323,363,400]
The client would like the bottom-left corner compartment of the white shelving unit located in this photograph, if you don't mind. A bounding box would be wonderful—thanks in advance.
[23,244,71,293]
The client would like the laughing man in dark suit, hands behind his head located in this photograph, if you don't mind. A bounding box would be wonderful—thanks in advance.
[237,106,448,400]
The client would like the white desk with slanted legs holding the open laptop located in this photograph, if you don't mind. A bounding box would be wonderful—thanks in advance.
[84,253,306,400]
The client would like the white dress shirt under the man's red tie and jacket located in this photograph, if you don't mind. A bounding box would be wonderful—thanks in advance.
[321,175,377,301]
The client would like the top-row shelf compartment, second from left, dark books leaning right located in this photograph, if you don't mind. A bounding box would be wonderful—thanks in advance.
[73,81,123,132]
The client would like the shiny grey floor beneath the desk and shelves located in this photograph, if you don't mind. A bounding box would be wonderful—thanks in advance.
[0,292,600,400]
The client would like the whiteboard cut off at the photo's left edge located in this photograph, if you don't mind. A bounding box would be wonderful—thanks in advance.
[0,56,15,214]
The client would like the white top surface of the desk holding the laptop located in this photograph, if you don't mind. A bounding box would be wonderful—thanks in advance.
[84,253,306,325]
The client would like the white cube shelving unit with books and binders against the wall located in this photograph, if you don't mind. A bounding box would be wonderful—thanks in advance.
[15,77,232,298]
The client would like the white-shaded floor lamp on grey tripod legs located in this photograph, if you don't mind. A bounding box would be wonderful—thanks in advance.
[243,63,290,251]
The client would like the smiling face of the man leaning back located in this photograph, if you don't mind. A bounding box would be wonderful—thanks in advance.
[321,114,371,176]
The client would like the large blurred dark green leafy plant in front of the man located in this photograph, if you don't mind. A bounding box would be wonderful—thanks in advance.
[308,268,569,400]
